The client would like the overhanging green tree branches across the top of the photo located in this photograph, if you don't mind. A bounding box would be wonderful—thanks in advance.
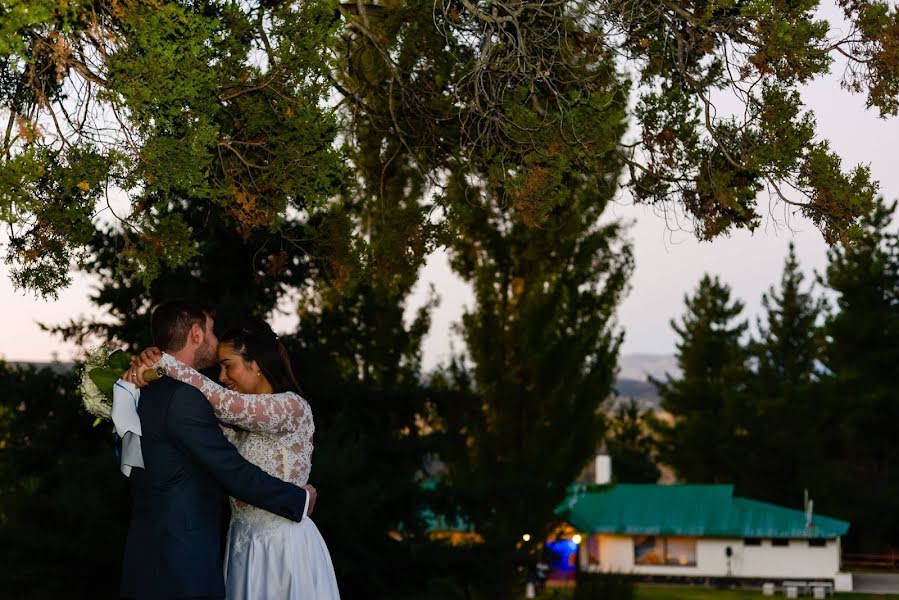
[0,0,899,294]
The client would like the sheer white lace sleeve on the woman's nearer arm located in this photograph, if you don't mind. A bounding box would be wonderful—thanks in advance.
[158,354,306,434]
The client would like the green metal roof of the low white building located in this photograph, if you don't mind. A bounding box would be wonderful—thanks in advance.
[558,483,849,538]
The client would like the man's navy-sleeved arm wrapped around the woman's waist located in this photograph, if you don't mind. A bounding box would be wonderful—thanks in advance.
[167,386,309,521]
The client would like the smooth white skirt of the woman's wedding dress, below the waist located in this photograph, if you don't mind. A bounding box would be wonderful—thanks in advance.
[225,511,340,600]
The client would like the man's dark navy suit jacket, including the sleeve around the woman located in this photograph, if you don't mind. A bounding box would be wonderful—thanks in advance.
[121,377,306,600]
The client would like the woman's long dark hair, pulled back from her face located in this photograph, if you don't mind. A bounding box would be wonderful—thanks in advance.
[219,317,303,395]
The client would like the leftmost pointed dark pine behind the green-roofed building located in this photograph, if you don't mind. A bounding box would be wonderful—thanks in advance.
[653,275,749,483]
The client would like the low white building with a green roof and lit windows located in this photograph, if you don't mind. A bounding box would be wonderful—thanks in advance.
[564,484,851,589]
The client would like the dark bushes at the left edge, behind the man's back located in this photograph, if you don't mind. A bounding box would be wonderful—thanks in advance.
[0,362,129,600]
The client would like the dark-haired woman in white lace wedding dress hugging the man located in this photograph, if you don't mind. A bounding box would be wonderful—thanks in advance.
[126,319,339,600]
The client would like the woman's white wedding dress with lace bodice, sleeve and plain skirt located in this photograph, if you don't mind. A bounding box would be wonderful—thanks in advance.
[159,354,340,600]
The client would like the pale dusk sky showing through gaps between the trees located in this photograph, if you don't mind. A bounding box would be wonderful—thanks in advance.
[0,5,899,367]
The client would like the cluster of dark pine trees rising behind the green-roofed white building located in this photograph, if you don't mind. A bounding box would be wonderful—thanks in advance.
[644,203,899,552]
